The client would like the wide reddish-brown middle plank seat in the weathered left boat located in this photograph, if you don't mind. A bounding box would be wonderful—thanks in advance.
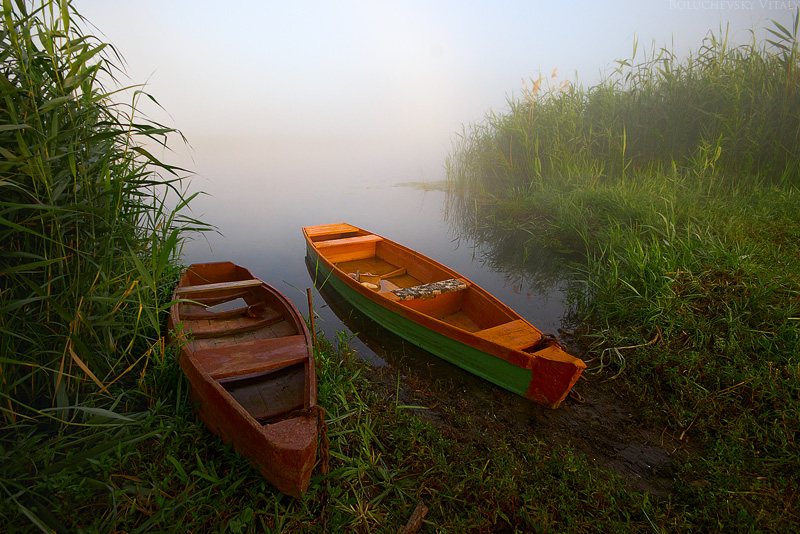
[194,335,308,380]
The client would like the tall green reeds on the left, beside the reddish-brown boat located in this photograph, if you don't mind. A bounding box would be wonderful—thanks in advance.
[0,0,203,425]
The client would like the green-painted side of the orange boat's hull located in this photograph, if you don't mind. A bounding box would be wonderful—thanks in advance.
[307,253,532,397]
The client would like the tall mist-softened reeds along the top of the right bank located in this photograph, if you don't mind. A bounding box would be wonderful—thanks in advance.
[446,17,800,203]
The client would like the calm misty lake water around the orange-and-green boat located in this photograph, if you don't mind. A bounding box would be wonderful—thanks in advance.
[184,181,566,372]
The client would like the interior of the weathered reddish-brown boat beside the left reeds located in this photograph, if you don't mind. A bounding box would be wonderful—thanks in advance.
[177,262,313,424]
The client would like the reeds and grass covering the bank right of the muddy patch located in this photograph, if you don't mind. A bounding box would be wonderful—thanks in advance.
[448,11,800,531]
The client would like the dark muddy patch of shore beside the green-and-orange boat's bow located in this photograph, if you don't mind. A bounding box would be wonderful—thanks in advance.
[369,346,685,496]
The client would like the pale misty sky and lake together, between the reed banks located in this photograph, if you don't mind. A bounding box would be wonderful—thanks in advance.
[77,0,793,364]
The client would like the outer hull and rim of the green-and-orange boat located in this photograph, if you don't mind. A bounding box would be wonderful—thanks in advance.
[304,227,585,408]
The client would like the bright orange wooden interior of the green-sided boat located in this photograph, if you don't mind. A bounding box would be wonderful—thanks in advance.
[306,224,552,353]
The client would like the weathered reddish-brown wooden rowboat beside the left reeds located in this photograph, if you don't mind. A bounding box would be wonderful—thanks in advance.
[169,262,321,497]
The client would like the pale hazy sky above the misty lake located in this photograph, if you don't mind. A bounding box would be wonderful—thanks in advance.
[74,0,800,186]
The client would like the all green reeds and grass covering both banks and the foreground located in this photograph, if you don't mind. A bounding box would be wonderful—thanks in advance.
[0,0,800,532]
